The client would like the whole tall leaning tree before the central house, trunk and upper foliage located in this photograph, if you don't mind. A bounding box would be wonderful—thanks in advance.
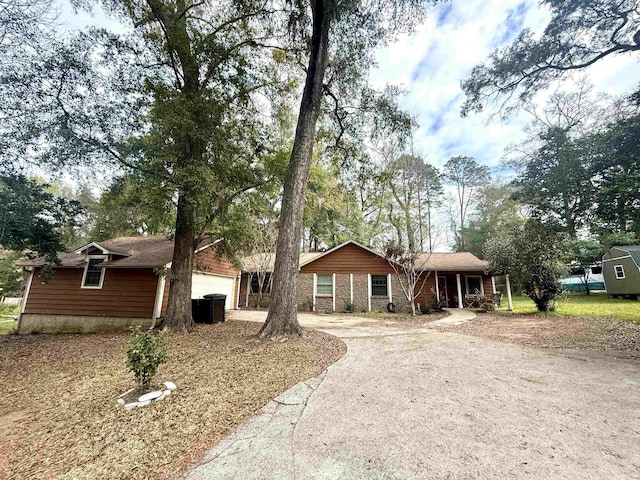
[260,0,427,337]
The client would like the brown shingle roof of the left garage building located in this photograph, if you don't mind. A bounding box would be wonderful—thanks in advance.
[19,237,221,268]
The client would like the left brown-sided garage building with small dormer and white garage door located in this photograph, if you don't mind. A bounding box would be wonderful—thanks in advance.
[18,237,239,333]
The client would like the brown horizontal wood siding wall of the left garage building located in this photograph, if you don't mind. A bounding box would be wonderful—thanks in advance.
[25,268,158,318]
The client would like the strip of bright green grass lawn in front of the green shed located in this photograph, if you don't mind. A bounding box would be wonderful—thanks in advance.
[500,293,640,325]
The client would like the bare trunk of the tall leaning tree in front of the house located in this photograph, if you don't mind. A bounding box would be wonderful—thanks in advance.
[259,0,333,338]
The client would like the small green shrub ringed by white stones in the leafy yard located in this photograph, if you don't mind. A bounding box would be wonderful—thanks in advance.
[127,326,167,388]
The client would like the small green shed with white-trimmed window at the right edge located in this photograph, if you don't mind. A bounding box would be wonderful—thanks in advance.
[602,245,640,298]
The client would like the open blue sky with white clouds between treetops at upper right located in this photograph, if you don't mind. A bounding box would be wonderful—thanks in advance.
[370,0,640,176]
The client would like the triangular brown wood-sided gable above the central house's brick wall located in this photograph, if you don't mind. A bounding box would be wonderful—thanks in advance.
[300,244,393,275]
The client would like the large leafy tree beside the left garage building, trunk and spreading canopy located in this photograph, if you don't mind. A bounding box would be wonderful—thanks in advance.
[0,0,286,329]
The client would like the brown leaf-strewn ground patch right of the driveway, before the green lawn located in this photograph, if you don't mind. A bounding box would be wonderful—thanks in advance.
[447,314,640,358]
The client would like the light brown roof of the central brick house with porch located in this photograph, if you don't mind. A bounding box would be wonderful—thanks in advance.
[242,240,489,272]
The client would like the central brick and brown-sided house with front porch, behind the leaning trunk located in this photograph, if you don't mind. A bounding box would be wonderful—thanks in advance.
[239,240,495,312]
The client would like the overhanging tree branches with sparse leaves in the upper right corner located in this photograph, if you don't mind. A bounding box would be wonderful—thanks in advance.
[462,0,640,116]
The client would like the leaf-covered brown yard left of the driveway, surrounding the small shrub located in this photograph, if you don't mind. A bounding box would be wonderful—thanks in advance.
[0,321,346,479]
